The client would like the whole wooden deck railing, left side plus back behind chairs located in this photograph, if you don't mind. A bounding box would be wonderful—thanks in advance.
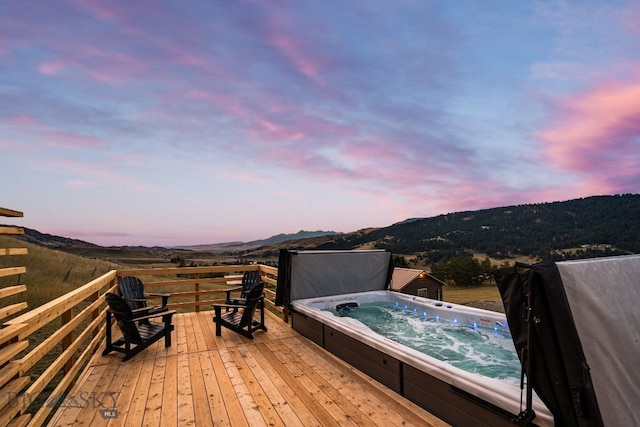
[0,265,288,426]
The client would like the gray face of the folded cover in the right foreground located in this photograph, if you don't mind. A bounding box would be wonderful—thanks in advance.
[556,255,640,426]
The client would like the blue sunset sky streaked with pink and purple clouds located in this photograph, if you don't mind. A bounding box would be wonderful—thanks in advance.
[0,0,640,246]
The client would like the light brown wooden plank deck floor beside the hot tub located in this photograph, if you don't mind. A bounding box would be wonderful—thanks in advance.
[49,312,447,427]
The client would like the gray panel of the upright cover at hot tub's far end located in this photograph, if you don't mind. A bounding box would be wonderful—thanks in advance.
[290,250,391,301]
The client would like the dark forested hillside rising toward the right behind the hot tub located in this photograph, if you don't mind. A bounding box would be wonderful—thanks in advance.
[235,194,640,263]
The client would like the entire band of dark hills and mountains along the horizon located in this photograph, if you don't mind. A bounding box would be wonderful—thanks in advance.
[6,194,640,263]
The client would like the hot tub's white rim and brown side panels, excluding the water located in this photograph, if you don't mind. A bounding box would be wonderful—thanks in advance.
[291,290,553,427]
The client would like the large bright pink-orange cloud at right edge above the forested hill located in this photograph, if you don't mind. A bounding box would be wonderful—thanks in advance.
[537,79,640,193]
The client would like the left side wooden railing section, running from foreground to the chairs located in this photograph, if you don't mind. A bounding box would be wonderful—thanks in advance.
[0,271,116,426]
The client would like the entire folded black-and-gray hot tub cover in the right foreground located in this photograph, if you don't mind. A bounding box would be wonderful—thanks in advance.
[496,255,640,426]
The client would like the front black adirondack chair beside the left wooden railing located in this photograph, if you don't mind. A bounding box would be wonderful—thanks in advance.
[102,292,176,362]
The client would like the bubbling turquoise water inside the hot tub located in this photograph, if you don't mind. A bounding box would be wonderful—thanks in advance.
[329,302,520,382]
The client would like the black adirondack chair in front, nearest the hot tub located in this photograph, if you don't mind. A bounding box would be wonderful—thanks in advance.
[212,282,267,339]
